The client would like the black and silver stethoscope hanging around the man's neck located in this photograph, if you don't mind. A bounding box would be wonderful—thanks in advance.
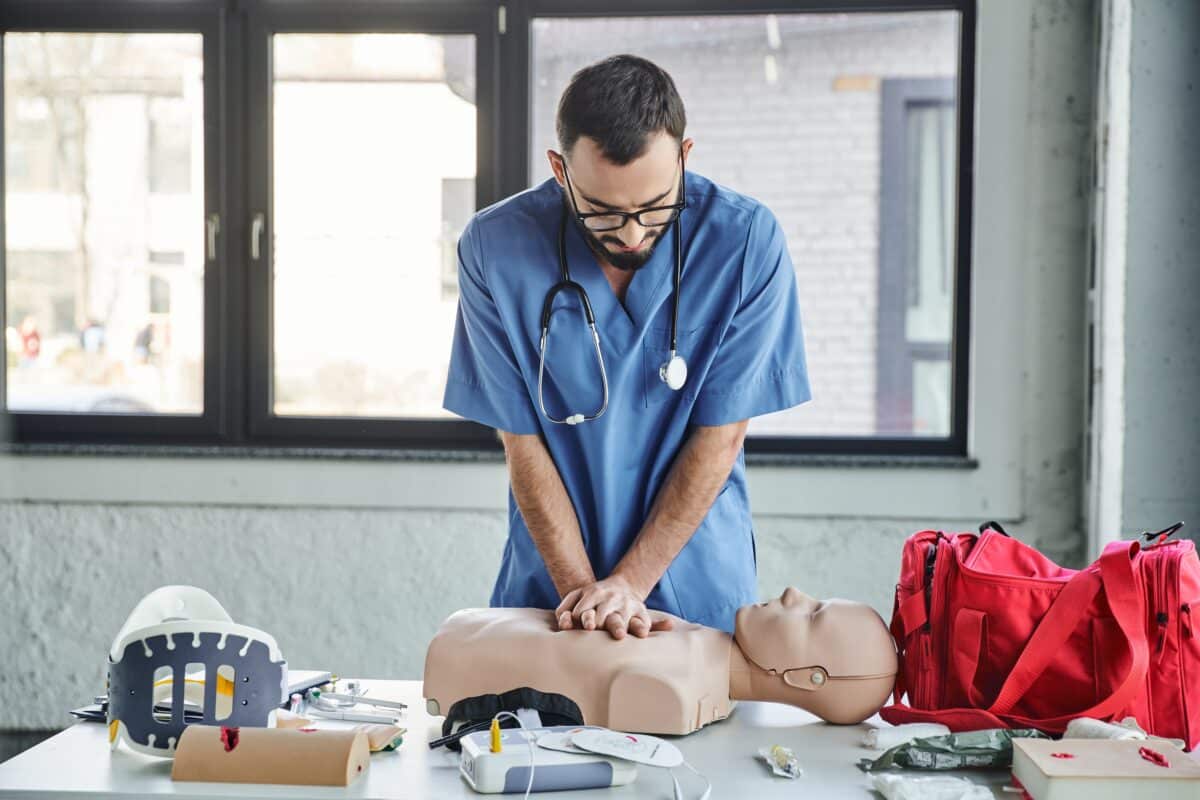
[538,200,688,425]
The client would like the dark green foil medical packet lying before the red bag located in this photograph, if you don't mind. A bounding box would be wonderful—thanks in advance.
[858,728,1048,772]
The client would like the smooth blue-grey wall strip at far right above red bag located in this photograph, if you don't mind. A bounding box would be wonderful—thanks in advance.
[1122,0,1200,539]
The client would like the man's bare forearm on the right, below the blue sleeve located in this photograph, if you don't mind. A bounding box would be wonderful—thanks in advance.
[613,421,746,597]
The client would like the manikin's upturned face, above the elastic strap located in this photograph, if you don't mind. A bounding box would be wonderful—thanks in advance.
[734,587,895,676]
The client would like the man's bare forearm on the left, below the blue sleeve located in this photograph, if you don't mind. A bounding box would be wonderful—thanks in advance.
[500,433,595,597]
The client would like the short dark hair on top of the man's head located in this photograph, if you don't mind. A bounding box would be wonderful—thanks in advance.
[557,55,688,166]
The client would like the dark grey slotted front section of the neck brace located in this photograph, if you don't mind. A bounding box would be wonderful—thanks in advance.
[108,633,288,751]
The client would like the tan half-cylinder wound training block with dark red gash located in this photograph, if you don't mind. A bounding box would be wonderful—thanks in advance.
[170,724,371,786]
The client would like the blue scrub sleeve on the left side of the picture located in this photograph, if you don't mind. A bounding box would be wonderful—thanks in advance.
[442,221,540,433]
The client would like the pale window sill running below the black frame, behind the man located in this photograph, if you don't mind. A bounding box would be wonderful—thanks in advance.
[0,444,1003,524]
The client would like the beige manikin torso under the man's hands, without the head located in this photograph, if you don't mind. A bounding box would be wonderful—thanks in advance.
[425,608,736,733]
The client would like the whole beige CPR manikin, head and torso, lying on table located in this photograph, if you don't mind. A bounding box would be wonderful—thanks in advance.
[425,588,896,734]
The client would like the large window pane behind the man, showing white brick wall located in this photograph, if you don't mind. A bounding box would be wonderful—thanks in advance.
[529,11,961,446]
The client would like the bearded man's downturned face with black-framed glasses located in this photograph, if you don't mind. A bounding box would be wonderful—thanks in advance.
[547,132,692,270]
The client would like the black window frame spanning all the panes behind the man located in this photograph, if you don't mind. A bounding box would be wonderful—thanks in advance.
[0,0,977,455]
